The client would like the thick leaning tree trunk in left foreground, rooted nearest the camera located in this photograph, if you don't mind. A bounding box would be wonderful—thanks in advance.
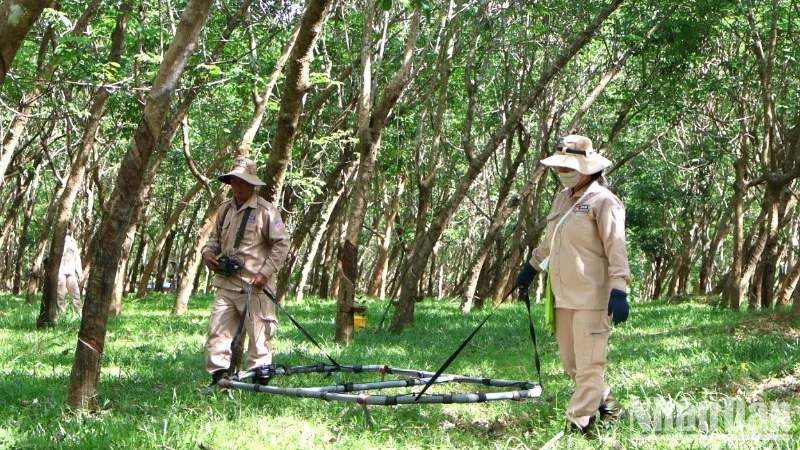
[67,0,211,409]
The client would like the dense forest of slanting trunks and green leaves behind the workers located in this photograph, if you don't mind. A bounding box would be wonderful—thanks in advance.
[0,0,800,407]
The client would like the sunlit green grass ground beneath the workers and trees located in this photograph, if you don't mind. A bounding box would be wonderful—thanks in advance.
[0,294,800,449]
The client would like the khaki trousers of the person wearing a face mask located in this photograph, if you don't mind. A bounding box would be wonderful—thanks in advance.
[556,308,611,427]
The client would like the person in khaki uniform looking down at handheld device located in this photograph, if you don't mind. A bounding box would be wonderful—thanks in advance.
[201,158,289,388]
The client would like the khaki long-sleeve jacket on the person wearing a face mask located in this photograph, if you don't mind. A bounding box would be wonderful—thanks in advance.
[530,182,631,310]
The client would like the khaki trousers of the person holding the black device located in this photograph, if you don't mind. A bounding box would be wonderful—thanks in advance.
[206,288,278,373]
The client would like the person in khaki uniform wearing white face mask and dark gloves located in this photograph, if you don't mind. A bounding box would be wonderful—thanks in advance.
[516,135,630,434]
